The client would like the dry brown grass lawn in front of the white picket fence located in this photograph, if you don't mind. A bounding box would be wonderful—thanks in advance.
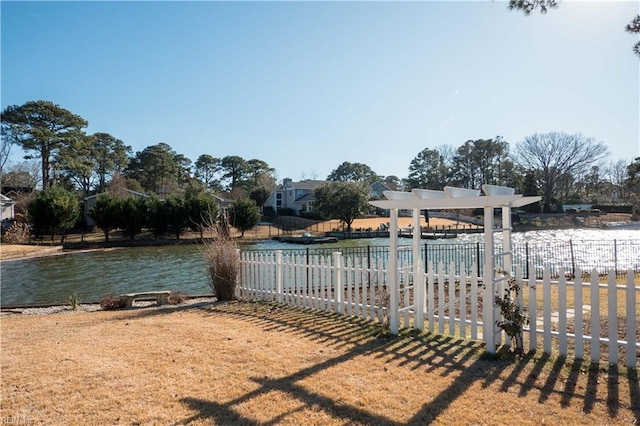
[0,302,640,425]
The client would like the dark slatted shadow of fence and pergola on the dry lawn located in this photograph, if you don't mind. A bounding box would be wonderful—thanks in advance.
[115,302,640,425]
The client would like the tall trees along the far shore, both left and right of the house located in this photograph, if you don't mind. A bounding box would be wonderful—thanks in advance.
[0,101,640,226]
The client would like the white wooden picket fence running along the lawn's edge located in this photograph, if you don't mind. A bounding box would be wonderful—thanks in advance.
[238,251,640,368]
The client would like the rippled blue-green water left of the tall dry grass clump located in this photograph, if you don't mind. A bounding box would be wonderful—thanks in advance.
[0,245,211,306]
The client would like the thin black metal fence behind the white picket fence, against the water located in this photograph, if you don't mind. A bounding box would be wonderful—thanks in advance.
[241,240,640,279]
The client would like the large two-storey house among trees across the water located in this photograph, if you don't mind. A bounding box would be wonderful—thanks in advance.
[264,178,327,215]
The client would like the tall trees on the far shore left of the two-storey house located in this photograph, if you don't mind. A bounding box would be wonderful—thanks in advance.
[0,100,275,205]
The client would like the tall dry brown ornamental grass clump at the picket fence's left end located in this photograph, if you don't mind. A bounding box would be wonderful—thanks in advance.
[204,227,240,300]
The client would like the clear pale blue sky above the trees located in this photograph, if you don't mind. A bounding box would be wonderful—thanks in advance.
[0,1,640,181]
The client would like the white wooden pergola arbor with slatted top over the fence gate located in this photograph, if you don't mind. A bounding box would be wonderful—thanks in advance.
[370,185,541,352]
